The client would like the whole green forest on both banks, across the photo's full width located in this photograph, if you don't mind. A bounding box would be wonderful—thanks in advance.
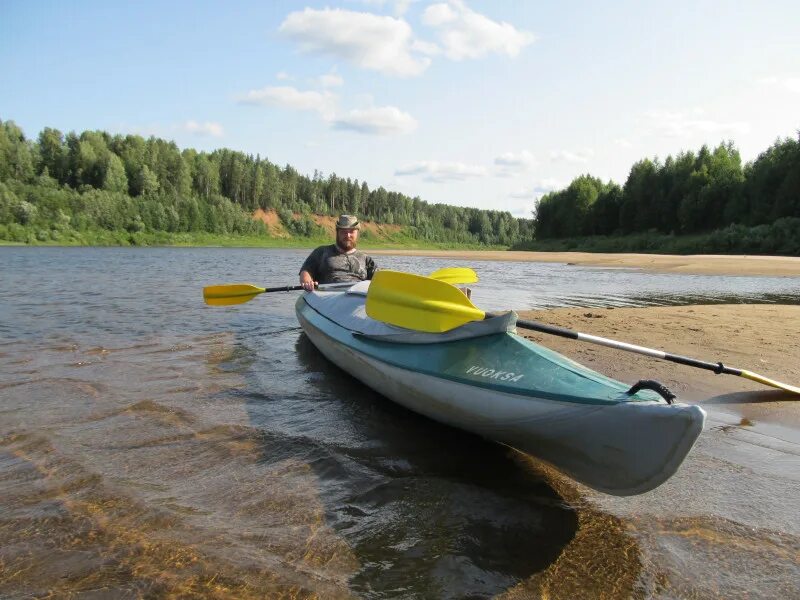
[0,120,800,255]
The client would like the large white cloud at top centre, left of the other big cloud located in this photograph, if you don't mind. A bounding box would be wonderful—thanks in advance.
[279,8,430,77]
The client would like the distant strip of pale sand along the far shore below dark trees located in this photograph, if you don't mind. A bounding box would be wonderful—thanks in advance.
[368,250,800,277]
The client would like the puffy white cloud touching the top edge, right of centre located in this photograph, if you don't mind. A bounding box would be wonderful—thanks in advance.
[422,0,535,60]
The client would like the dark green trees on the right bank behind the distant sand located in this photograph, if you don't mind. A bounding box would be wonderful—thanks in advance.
[534,134,800,244]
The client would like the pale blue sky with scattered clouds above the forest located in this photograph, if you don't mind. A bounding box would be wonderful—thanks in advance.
[0,0,800,216]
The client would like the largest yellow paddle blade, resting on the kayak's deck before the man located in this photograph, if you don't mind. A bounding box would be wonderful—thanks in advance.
[366,271,484,333]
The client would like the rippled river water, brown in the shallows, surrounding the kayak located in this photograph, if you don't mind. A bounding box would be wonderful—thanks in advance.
[0,247,800,598]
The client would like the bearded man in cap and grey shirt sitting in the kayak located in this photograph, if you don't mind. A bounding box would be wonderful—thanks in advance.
[300,215,378,292]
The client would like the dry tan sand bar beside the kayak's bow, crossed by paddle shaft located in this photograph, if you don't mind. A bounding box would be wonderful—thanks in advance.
[519,304,800,427]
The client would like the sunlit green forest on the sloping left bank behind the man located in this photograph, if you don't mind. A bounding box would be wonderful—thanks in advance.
[0,120,533,246]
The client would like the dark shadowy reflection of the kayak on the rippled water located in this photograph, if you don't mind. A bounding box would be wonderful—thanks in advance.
[296,335,577,598]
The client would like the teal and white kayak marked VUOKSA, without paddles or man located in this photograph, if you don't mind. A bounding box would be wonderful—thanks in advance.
[296,293,705,496]
